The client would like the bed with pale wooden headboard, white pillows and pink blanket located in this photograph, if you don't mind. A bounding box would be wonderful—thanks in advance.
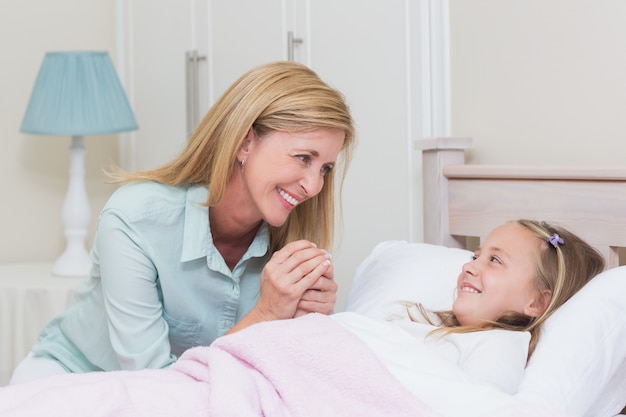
[0,138,626,417]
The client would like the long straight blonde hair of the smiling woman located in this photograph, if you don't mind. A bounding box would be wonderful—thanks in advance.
[113,61,356,253]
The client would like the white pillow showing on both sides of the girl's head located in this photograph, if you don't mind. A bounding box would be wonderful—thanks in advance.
[345,241,626,417]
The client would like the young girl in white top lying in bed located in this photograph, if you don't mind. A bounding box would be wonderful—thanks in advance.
[333,219,604,415]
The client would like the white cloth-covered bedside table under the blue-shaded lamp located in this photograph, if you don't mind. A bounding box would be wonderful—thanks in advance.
[0,263,84,385]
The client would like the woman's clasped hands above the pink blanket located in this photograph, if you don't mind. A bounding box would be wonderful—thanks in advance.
[228,240,337,333]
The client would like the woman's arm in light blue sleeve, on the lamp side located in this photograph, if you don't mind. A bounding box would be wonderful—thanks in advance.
[94,210,175,369]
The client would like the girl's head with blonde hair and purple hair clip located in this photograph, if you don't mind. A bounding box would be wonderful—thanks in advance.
[412,219,604,357]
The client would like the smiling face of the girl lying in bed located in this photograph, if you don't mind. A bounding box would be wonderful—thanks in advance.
[452,223,545,326]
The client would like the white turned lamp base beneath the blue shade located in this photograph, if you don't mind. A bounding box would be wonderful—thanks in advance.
[52,136,91,277]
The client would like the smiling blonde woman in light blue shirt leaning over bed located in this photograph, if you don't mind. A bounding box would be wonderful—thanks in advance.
[11,62,354,384]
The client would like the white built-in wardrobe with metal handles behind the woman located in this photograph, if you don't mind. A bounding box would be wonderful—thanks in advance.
[117,0,445,311]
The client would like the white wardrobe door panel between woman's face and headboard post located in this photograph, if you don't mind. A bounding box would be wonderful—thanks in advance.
[298,0,421,309]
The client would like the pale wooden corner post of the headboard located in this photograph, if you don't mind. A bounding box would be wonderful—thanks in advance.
[414,137,472,248]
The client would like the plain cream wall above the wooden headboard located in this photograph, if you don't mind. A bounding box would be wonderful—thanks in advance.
[449,0,626,165]
